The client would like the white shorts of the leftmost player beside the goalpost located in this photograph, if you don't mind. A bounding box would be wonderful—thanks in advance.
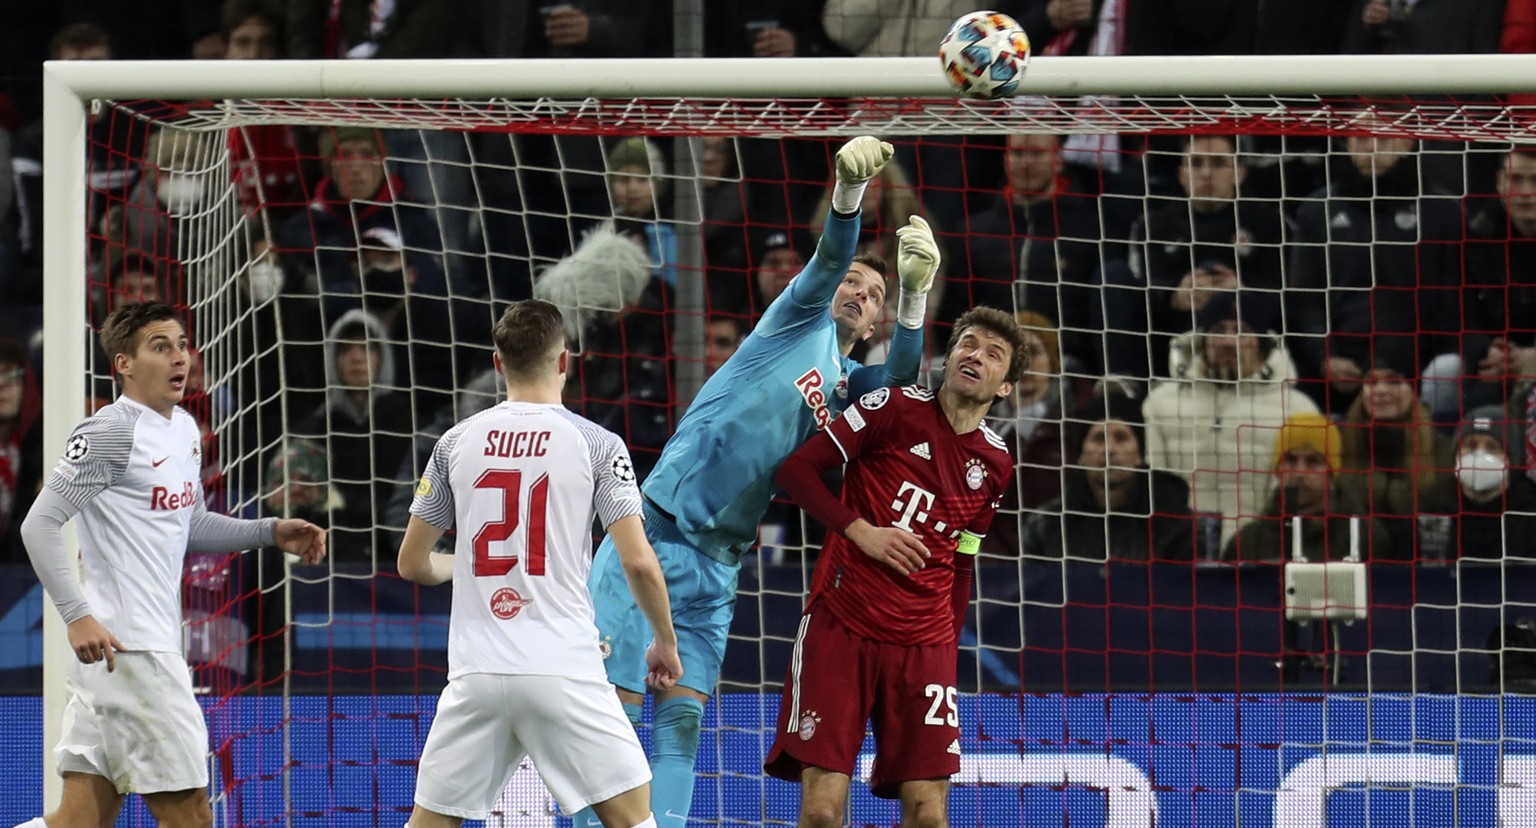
[54,653,207,794]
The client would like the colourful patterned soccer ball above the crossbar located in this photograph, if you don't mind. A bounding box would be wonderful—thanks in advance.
[938,11,1029,98]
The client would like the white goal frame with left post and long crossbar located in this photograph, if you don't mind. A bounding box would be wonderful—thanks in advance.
[43,55,1536,810]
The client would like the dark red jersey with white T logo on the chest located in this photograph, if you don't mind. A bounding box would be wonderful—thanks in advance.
[806,386,1014,647]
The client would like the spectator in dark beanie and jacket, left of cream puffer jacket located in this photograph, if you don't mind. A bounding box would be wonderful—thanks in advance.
[1023,393,1193,561]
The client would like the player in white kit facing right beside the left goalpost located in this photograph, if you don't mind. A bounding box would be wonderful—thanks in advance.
[18,303,326,828]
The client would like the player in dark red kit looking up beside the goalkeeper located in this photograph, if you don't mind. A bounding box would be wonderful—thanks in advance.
[763,307,1029,828]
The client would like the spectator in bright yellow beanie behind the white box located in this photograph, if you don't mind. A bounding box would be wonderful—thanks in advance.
[1221,412,1389,561]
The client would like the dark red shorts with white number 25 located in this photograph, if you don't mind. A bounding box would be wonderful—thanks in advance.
[763,610,960,799]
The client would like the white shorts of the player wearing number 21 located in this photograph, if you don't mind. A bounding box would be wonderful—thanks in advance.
[416,673,651,819]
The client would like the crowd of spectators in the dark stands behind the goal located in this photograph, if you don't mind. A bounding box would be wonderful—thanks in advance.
[0,0,1536,580]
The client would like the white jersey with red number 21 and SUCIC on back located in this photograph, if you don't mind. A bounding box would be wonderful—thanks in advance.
[410,401,641,679]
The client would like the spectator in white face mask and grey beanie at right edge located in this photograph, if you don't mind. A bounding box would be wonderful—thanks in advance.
[1456,406,1536,559]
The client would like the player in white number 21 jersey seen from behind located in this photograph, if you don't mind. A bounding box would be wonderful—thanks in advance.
[399,300,682,828]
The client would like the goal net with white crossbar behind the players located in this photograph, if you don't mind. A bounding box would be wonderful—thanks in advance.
[33,57,1536,828]
